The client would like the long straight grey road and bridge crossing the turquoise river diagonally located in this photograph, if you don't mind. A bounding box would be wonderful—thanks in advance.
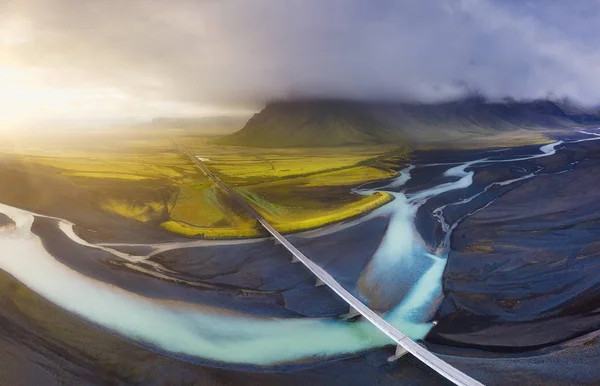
[181,146,482,386]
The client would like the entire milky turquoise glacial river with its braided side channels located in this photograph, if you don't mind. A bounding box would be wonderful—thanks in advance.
[0,132,600,366]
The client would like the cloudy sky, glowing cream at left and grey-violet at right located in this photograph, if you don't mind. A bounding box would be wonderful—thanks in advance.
[0,0,600,126]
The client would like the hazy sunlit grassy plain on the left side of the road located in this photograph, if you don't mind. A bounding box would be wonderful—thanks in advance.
[0,133,260,238]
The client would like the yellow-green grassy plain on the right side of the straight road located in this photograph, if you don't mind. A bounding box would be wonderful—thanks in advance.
[187,139,409,233]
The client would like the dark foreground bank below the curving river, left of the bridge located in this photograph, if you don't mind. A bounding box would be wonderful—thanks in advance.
[0,272,448,386]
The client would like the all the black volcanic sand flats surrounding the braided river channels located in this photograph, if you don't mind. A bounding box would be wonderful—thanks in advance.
[5,134,600,385]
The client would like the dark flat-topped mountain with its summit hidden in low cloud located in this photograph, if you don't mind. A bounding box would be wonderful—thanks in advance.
[215,98,600,147]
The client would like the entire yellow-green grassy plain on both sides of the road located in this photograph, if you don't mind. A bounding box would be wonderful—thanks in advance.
[0,132,408,238]
